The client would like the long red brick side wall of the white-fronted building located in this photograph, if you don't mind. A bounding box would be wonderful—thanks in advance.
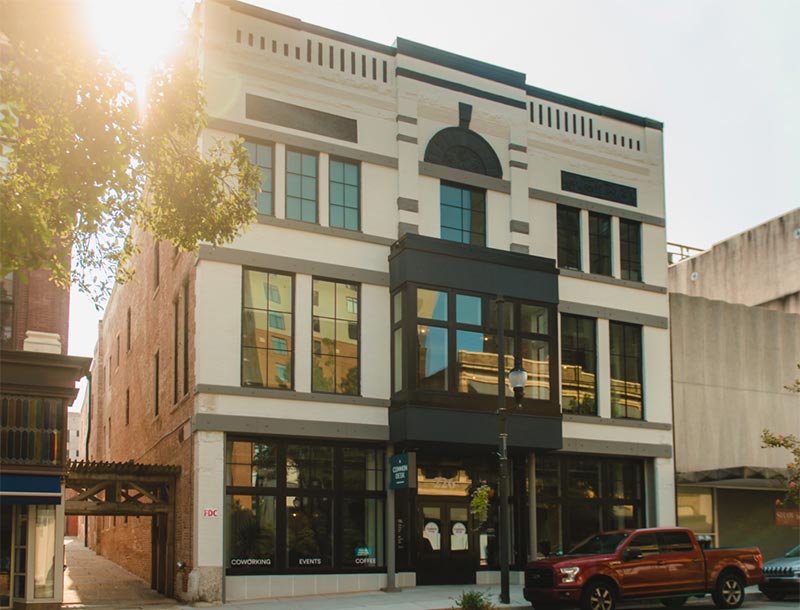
[89,234,195,582]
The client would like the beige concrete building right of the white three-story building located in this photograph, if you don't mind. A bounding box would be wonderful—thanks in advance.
[669,209,800,557]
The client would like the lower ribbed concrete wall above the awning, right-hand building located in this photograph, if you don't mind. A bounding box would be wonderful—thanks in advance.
[670,294,800,472]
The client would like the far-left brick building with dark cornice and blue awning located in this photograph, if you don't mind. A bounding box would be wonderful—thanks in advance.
[0,271,90,608]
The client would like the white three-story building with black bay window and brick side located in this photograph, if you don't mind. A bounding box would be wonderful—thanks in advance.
[88,0,675,601]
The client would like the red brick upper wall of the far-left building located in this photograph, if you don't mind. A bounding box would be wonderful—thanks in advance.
[8,270,69,354]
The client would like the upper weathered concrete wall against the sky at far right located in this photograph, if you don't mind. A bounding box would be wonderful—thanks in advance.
[669,208,800,313]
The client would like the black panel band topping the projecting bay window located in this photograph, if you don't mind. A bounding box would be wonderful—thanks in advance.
[389,234,558,303]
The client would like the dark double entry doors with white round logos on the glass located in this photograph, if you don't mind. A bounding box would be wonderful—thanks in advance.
[416,497,478,585]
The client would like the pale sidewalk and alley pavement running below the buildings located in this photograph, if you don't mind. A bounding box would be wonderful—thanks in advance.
[62,538,800,610]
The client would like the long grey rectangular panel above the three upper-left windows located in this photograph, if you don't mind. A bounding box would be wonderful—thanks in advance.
[245,93,358,142]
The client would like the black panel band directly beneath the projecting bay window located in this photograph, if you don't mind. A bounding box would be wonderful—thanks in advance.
[389,405,562,449]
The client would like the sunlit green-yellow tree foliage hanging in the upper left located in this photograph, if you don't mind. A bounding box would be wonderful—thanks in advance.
[0,0,259,302]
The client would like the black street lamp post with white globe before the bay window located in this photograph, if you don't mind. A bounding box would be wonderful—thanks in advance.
[495,296,528,604]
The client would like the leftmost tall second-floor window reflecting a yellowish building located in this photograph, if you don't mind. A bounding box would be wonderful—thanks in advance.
[242,269,293,388]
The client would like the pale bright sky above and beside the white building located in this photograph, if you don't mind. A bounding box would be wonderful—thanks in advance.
[65,0,800,390]
